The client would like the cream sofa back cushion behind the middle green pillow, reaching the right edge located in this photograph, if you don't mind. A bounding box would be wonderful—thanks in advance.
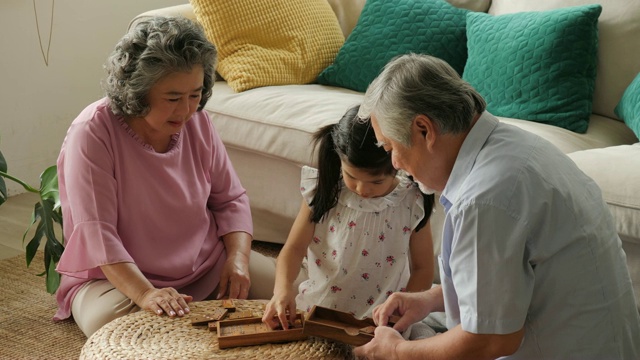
[489,0,640,118]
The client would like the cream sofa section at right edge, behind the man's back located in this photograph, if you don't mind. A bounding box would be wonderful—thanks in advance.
[569,143,640,244]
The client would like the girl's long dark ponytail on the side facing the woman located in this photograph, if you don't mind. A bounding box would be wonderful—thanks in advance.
[309,124,341,223]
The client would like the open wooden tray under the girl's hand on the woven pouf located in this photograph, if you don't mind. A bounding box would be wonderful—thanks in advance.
[217,314,307,349]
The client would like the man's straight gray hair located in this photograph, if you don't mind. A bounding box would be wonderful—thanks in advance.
[358,54,486,147]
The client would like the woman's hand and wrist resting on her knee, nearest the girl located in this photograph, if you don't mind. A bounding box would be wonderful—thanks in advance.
[217,252,251,299]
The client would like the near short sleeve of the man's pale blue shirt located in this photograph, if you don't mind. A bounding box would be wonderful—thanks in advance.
[450,203,535,334]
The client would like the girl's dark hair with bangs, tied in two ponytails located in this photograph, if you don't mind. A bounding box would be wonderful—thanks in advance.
[309,105,434,231]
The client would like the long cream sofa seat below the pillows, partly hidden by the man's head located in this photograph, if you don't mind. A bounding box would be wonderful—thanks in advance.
[205,81,636,170]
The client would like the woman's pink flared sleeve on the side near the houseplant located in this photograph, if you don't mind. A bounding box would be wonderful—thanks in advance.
[57,111,133,277]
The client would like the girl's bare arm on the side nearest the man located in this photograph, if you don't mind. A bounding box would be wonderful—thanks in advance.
[407,220,434,292]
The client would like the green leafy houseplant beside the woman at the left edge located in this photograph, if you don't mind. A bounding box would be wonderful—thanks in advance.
[0,145,64,294]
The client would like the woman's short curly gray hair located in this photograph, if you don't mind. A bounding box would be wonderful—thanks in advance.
[102,17,217,117]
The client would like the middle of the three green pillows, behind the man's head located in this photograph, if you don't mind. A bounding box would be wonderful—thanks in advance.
[463,5,602,133]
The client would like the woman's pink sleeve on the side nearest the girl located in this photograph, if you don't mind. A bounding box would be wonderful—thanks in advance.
[205,116,253,237]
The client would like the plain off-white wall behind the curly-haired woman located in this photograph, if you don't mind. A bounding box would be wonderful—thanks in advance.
[0,0,188,195]
